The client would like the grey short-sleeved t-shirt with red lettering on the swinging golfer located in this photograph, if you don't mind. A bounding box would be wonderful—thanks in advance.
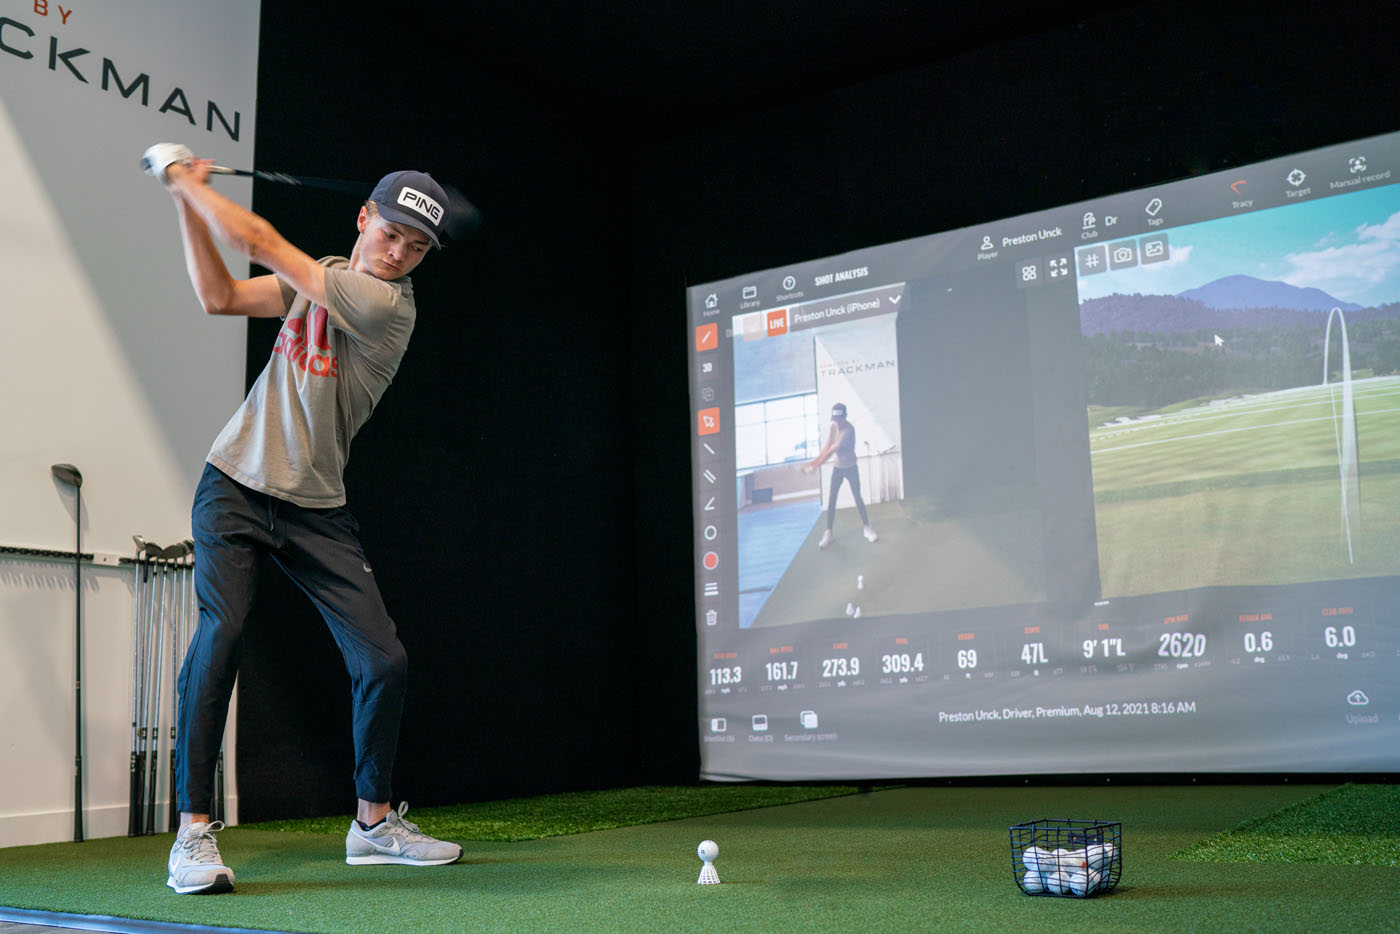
[209,256,417,508]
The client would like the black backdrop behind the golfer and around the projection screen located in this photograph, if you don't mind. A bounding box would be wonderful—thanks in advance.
[238,1,1400,821]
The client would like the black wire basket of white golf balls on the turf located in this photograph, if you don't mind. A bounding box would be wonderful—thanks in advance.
[1011,818,1123,898]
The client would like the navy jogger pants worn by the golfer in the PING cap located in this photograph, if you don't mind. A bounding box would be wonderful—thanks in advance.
[175,463,407,814]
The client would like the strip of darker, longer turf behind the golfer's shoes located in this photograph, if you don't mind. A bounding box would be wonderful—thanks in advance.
[242,786,857,843]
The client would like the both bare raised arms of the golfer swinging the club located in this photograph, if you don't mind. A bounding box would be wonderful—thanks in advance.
[165,164,326,316]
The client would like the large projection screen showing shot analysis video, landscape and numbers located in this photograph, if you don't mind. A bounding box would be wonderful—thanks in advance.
[687,128,1400,780]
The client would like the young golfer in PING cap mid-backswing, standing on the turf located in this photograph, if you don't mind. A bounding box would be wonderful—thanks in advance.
[143,143,462,893]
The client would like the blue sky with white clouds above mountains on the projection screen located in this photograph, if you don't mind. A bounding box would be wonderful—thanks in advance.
[1078,185,1400,307]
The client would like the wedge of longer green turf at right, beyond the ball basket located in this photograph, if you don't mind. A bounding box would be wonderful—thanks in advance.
[1172,784,1400,867]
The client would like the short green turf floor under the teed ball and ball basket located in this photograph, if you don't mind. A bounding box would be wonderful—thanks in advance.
[0,786,1400,931]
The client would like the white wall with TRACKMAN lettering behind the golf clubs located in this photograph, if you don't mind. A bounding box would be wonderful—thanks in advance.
[0,0,259,846]
